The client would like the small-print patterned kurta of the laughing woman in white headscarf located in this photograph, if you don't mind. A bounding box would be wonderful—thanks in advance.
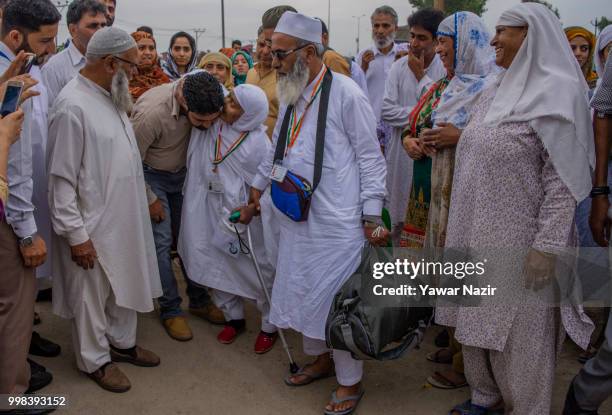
[436,85,592,351]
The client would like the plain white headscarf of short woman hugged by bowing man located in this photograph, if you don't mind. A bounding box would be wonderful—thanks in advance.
[232,84,268,135]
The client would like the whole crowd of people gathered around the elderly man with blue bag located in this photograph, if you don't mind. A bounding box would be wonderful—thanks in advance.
[0,0,612,415]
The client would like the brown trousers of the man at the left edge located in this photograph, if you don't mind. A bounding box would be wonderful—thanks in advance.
[0,220,36,394]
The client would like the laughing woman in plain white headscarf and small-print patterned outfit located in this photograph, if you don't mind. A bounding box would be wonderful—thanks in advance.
[436,3,594,415]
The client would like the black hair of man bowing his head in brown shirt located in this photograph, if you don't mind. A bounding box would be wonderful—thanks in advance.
[183,71,224,114]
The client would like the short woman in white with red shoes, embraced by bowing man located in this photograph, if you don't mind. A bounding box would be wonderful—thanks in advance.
[179,85,276,353]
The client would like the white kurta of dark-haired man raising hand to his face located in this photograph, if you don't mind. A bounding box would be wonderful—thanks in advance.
[382,54,446,227]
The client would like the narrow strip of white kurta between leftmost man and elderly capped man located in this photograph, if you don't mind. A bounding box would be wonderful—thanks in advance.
[30,66,53,278]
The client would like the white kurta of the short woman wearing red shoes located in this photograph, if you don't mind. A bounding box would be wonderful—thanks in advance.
[178,120,274,303]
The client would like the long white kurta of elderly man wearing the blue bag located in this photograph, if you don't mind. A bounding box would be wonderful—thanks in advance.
[253,68,386,340]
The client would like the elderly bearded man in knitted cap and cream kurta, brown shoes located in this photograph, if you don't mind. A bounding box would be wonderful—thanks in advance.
[47,27,161,392]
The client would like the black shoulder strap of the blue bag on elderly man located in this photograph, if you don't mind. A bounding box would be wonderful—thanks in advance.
[274,68,333,192]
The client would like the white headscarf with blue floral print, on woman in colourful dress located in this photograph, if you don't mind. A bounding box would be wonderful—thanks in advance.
[432,12,497,129]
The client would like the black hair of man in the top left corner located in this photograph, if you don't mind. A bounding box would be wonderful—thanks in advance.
[2,0,62,37]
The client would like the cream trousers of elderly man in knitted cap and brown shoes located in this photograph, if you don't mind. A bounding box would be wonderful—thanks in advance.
[72,263,137,373]
